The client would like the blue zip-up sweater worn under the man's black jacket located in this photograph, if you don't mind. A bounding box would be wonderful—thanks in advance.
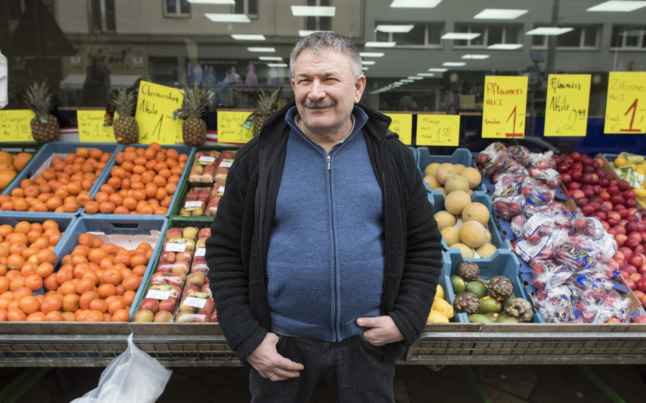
[267,107,384,341]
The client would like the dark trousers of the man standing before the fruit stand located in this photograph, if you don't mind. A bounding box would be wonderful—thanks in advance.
[249,335,395,403]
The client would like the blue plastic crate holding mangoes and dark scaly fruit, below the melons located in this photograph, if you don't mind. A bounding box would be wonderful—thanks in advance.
[442,250,545,323]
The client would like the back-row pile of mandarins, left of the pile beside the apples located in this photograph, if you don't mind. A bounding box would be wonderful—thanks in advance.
[0,147,112,213]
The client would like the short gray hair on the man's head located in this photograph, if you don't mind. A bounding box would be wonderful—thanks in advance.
[289,32,361,79]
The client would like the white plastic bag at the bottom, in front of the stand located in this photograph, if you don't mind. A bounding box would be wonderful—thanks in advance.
[72,333,173,403]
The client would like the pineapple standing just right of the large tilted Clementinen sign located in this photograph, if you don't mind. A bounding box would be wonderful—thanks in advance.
[180,83,210,146]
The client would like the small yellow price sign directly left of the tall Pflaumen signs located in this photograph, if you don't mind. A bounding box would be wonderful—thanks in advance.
[416,115,460,147]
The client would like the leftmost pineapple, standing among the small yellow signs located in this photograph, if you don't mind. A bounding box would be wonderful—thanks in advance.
[25,82,60,143]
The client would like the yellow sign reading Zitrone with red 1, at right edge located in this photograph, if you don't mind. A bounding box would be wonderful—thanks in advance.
[603,71,646,134]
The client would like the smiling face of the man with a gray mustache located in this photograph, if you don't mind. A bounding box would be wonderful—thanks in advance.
[292,49,366,137]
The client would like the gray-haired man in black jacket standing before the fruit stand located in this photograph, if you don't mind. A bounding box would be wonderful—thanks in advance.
[206,33,442,402]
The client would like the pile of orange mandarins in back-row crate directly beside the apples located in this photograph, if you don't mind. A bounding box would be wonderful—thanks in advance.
[84,143,188,215]
